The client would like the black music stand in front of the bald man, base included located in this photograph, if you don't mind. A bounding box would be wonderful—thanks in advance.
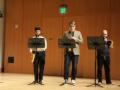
[87,36,105,87]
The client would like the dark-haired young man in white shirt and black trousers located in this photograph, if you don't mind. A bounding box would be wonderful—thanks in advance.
[30,27,47,85]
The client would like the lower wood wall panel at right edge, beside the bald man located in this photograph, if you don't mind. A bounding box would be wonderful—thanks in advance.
[110,13,120,79]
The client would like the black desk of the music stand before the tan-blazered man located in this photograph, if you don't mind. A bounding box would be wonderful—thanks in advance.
[58,38,75,48]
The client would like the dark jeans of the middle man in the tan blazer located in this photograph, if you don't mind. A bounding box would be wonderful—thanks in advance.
[64,53,79,80]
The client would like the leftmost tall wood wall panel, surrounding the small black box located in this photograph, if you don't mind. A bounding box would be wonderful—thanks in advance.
[4,0,23,72]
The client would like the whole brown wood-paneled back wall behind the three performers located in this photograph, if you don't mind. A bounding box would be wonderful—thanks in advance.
[4,0,120,79]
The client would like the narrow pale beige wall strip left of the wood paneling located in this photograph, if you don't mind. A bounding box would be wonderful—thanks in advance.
[0,0,4,71]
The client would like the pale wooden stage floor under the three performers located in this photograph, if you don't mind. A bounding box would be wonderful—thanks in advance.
[0,73,120,90]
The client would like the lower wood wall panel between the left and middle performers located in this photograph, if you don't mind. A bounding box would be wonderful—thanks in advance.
[43,18,63,75]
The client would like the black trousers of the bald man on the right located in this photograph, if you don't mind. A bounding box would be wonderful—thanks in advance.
[97,56,111,84]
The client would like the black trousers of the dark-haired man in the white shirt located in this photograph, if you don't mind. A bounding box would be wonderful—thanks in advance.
[33,51,45,82]
